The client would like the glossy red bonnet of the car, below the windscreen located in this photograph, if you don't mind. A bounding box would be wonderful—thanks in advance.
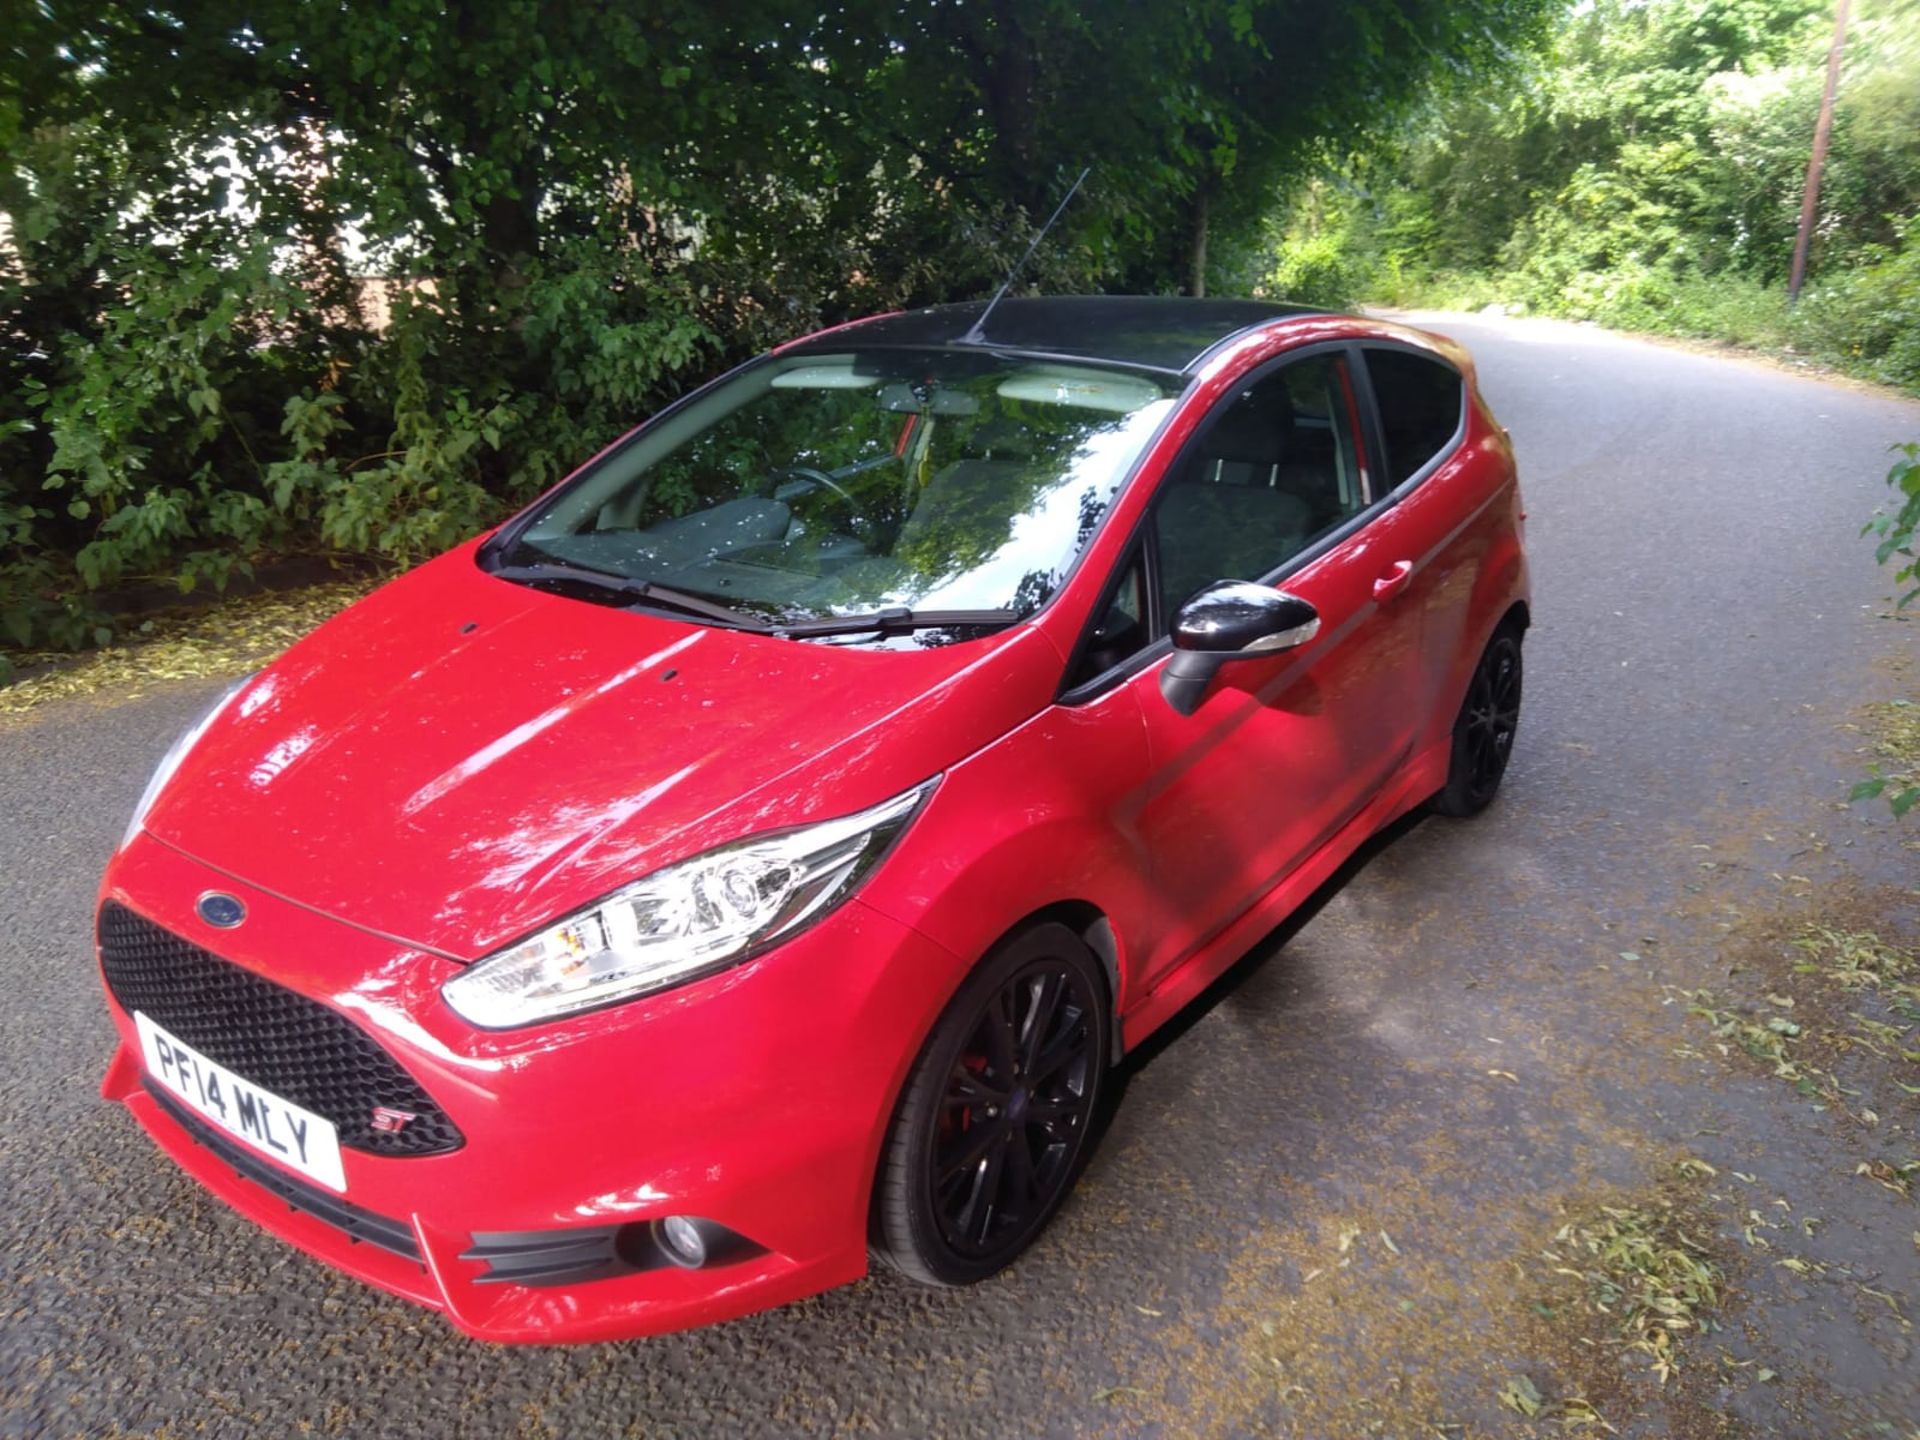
[144,545,1060,960]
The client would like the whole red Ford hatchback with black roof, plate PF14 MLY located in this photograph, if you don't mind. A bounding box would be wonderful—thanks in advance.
[98,298,1528,1342]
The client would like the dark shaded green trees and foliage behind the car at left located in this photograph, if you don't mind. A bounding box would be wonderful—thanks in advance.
[0,0,1544,664]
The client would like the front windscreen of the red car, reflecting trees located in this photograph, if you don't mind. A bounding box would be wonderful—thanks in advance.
[505,349,1173,624]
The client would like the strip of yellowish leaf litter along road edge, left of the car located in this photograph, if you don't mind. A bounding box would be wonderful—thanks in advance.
[0,578,380,716]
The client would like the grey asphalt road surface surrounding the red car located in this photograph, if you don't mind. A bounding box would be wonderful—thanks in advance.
[0,317,1920,1438]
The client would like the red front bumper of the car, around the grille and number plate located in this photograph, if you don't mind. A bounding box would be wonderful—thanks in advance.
[102,833,962,1344]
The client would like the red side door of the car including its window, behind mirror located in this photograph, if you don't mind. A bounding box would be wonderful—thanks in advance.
[1127,348,1421,985]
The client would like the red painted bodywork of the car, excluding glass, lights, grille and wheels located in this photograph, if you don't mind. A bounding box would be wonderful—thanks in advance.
[102,301,1528,1342]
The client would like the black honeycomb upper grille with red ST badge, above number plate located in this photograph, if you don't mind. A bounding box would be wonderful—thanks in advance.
[100,902,461,1156]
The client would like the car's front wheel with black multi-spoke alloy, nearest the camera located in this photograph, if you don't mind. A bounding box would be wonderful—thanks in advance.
[874,924,1112,1286]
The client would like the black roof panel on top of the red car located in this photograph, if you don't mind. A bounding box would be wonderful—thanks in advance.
[793,296,1317,372]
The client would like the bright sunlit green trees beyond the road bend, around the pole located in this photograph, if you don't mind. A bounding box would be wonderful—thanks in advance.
[1263,0,1920,388]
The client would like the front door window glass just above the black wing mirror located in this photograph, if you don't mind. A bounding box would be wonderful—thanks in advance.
[1154,355,1369,616]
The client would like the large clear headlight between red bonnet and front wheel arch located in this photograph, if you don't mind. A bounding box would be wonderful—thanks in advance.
[442,780,935,1029]
